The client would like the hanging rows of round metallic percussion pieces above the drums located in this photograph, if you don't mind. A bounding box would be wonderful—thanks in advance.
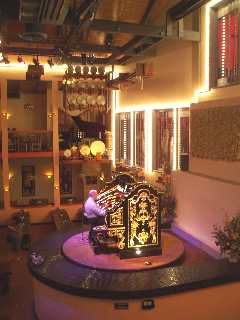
[62,65,108,116]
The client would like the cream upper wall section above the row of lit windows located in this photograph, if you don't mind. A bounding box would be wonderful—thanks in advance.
[120,40,198,108]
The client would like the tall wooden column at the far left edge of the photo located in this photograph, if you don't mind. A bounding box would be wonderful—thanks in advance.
[0,79,10,209]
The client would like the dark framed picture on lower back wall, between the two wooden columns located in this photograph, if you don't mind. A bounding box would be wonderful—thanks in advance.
[22,166,36,197]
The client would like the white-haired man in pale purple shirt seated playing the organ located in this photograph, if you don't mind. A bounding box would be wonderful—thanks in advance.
[84,190,106,241]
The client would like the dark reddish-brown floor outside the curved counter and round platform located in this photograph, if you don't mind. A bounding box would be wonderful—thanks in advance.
[0,224,212,320]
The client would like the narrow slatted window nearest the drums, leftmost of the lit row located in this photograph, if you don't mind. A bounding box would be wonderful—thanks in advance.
[116,112,131,165]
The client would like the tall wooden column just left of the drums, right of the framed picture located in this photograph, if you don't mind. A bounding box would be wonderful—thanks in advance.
[52,80,60,207]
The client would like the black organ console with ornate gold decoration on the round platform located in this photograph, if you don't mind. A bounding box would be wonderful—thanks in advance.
[96,174,161,258]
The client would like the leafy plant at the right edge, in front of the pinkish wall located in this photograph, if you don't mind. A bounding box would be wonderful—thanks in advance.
[213,214,240,262]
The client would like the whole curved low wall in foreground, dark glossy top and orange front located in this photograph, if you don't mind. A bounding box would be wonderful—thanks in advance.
[29,228,240,320]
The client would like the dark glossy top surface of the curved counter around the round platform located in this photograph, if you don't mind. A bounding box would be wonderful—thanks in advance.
[29,228,240,298]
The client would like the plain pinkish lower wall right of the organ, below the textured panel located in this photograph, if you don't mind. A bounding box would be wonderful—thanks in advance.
[173,171,240,250]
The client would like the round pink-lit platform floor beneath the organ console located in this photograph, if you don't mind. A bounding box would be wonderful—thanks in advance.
[62,231,184,271]
